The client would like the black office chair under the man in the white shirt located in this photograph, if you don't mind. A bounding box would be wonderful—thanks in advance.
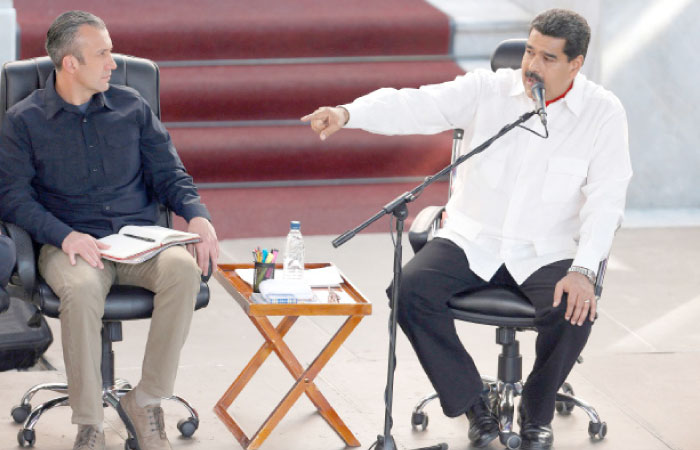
[408,39,607,449]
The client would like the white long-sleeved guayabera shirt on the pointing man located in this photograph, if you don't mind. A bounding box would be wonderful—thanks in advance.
[344,69,632,283]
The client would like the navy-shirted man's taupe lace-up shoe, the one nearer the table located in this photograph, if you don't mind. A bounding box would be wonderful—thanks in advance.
[119,391,172,450]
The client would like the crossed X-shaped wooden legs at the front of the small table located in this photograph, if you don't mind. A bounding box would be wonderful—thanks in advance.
[248,316,363,449]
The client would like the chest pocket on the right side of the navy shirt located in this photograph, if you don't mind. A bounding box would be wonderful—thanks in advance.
[102,126,141,185]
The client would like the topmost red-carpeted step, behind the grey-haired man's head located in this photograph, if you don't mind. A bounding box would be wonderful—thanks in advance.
[19,0,450,61]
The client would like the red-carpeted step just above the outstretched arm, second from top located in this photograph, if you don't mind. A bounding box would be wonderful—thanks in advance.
[161,60,464,122]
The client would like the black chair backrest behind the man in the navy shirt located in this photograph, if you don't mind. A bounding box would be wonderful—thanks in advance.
[0,53,160,123]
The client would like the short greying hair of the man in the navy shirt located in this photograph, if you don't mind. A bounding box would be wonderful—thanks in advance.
[46,11,107,70]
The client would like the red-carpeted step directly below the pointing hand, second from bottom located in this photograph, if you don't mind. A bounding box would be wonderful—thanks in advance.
[170,126,452,185]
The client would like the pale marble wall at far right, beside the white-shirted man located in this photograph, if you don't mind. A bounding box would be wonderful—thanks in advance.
[601,0,700,209]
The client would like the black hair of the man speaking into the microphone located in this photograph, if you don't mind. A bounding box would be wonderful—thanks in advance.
[530,9,591,61]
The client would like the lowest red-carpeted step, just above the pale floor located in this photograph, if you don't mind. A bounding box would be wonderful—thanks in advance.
[175,181,448,241]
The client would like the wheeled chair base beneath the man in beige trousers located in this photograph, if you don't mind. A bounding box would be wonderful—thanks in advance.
[11,379,199,449]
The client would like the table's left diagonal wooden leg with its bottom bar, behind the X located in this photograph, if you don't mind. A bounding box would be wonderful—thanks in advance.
[214,316,298,449]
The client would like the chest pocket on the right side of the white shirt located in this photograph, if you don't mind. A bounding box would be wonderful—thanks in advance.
[542,157,588,202]
